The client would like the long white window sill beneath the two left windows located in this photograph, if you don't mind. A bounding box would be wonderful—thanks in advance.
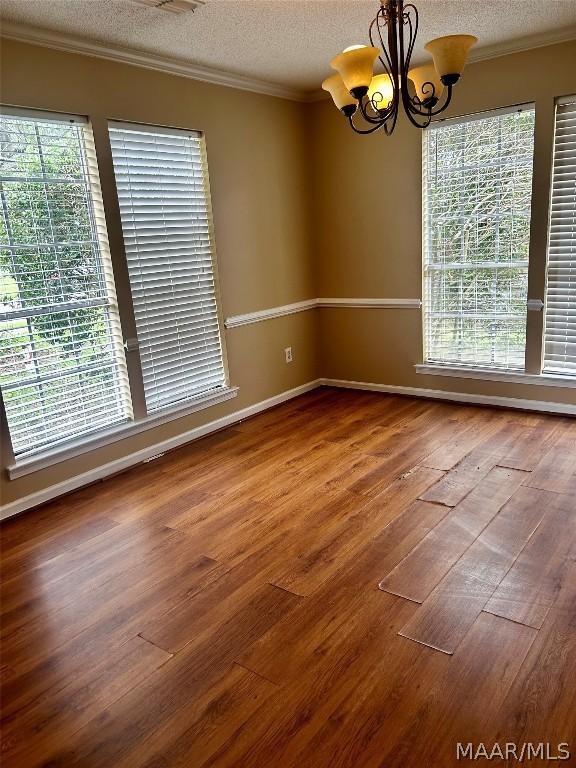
[7,387,239,480]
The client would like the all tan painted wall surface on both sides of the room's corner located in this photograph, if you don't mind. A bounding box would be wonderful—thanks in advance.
[0,41,576,510]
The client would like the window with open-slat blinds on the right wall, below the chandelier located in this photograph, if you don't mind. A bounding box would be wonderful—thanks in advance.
[423,108,534,369]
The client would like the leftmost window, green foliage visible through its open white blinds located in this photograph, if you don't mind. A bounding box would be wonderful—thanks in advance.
[0,109,132,457]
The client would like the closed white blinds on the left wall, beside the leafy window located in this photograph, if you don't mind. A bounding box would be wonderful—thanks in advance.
[110,123,226,412]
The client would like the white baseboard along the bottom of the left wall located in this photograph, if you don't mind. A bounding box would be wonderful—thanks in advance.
[0,379,321,520]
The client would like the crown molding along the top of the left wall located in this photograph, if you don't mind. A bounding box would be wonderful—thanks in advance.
[0,21,306,101]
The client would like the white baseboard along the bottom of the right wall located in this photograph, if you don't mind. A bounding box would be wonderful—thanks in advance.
[320,379,576,416]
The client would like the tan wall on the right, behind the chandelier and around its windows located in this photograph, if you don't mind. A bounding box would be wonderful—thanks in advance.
[309,42,576,403]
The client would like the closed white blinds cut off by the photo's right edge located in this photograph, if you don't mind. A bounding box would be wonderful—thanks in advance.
[544,97,576,376]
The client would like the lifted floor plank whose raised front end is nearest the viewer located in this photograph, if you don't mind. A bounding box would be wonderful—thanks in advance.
[400,487,547,654]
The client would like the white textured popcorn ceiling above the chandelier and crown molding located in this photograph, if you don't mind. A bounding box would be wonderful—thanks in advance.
[1,0,576,90]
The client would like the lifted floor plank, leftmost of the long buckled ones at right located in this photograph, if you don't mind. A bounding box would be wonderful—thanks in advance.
[380,467,525,603]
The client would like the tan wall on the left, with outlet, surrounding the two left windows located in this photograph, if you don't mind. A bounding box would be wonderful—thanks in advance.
[0,41,318,503]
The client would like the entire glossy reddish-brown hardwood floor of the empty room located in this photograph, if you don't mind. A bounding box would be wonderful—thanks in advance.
[1,389,576,768]
